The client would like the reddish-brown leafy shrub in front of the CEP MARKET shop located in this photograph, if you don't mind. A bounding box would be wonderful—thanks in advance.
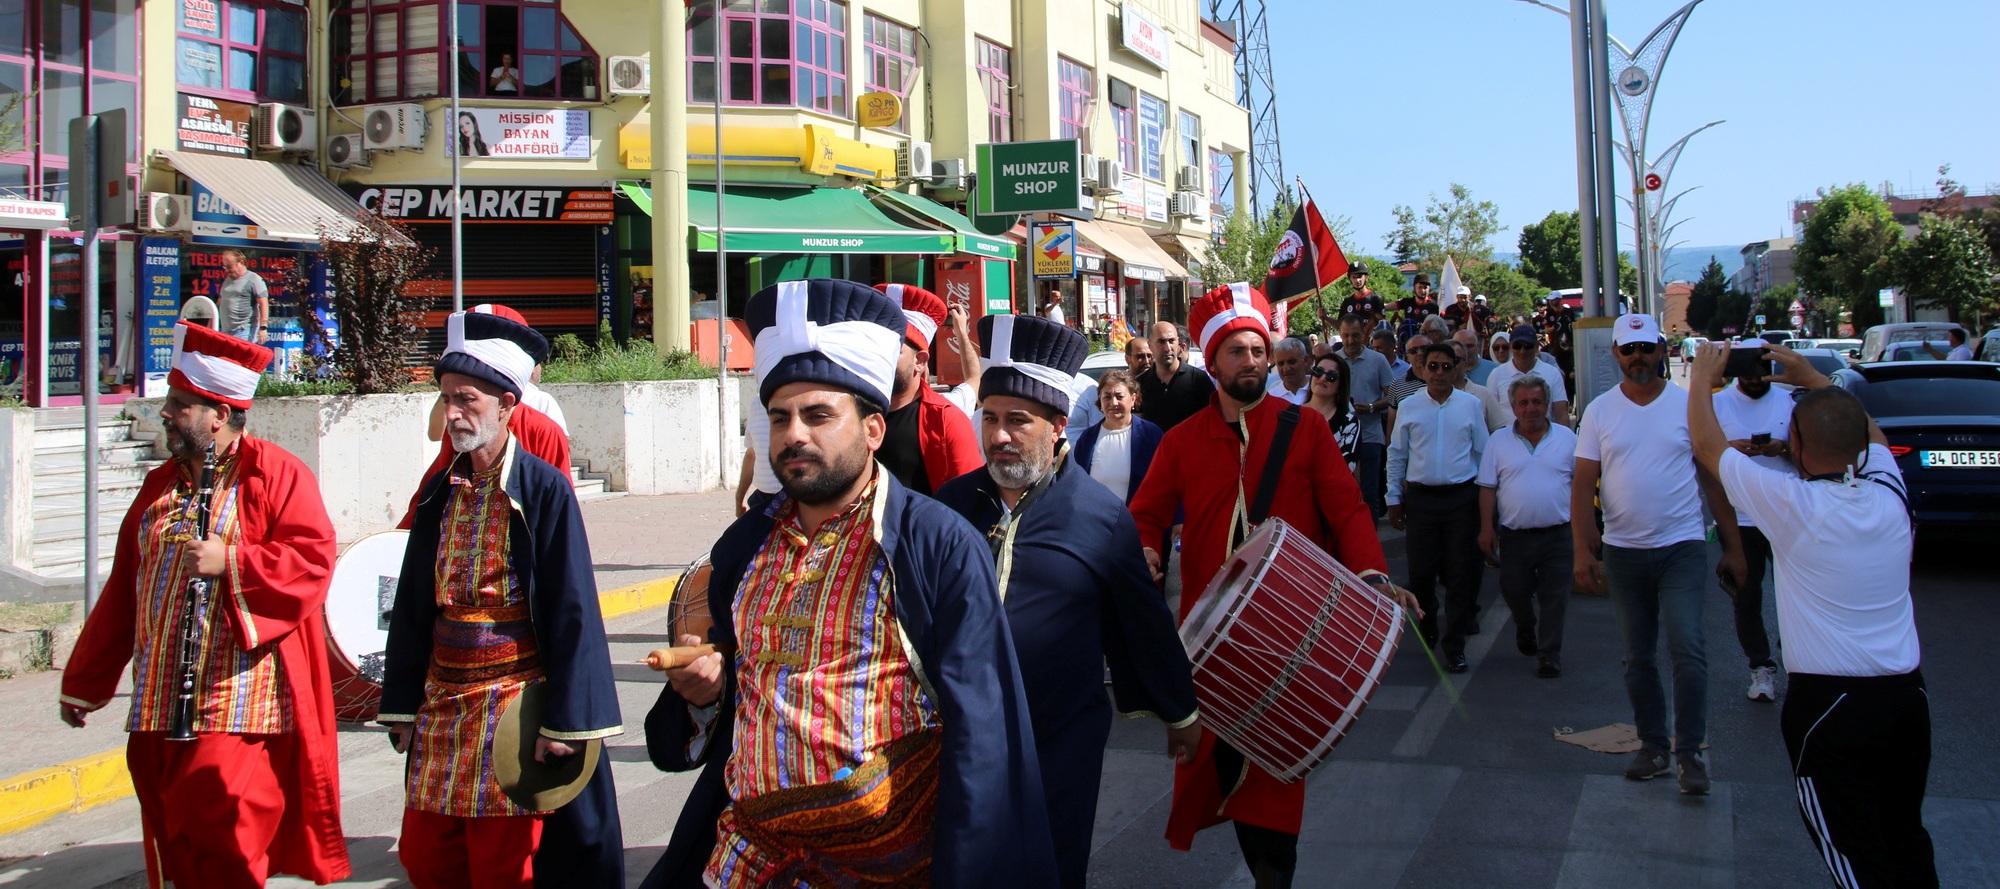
[288,212,436,394]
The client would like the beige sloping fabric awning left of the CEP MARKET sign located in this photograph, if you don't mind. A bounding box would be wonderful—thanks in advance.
[156,150,378,242]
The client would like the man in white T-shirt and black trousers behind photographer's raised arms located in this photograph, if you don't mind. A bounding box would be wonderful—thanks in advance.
[1714,356,1792,701]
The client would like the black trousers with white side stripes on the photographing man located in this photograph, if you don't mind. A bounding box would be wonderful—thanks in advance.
[1782,671,1938,889]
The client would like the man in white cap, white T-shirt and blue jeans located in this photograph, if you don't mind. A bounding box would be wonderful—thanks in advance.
[1568,314,1744,795]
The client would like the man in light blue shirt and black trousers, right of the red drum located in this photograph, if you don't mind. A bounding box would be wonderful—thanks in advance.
[1388,342,1486,673]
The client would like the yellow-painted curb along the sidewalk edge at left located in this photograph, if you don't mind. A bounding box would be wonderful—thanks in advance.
[0,573,680,835]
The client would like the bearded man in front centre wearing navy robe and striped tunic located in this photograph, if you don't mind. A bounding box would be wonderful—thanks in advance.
[646,280,1056,889]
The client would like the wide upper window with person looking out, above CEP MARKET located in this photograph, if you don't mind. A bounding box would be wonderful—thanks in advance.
[328,0,598,104]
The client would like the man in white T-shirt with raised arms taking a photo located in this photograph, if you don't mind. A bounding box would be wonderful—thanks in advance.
[1688,342,1938,885]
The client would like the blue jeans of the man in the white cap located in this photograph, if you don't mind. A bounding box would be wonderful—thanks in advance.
[1580,541,1708,753]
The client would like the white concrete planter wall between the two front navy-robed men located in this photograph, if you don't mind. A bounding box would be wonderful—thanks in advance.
[544,380,744,495]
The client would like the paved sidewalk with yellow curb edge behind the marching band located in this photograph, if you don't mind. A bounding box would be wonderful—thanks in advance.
[0,491,736,835]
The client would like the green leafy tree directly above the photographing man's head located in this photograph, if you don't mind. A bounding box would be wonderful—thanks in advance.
[1792,182,1902,334]
